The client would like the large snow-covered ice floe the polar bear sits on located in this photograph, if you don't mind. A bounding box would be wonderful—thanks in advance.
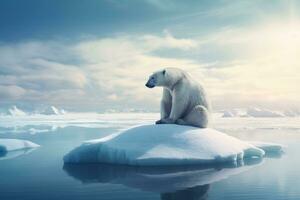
[64,124,284,165]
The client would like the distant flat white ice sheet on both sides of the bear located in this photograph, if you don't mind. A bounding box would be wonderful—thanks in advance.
[0,109,300,134]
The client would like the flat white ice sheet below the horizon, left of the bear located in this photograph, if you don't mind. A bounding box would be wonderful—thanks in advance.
[0,112,159,134]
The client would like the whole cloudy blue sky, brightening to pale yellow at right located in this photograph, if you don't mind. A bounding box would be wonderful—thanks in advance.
[0,0,300,112]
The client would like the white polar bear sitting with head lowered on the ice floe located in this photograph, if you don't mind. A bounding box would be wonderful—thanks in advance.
[146,68,210,128]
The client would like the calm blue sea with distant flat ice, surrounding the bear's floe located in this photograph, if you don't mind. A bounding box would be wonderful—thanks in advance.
[0,113,300,200]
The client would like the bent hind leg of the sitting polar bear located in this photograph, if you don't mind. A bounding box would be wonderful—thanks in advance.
[176,105,209,128]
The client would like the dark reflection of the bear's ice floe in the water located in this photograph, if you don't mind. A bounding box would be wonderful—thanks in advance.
[63,158,262,200]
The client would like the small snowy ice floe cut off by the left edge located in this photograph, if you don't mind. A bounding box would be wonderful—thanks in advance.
[0,139,40,152]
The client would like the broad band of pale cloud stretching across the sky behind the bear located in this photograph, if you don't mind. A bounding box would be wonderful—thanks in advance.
[0,24,300,110]
